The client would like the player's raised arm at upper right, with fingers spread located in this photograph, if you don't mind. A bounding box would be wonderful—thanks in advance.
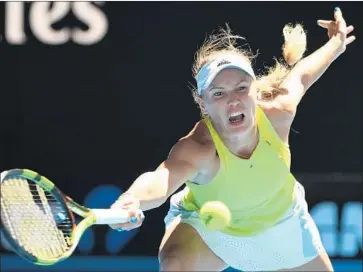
[281,8,355,109]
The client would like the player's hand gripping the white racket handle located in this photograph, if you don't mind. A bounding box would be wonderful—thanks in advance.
[110,193,144,231]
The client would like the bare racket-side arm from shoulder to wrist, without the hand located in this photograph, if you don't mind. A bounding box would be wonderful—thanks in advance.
[121,138,206,211]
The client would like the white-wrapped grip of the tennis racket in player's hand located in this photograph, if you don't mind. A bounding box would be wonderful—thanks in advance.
[91,209,143,225]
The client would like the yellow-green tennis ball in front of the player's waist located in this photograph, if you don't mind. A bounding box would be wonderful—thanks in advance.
[199,201,231,230]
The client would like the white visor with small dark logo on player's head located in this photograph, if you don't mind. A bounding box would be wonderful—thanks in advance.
[197,56,256,95]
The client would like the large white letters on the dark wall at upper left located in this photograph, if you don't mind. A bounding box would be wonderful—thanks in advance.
[4,1,109,46]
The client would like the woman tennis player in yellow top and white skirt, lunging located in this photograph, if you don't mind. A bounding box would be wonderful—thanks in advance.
[111,8,355,271]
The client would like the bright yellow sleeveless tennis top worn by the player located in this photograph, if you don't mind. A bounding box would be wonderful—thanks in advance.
[182,106,296,236]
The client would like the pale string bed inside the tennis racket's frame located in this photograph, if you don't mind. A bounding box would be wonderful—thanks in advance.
[1,179,73,259]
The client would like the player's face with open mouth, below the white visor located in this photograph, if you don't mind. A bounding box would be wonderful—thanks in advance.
[202,69,256,136]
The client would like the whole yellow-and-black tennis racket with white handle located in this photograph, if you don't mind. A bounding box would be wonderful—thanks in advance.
[0,169,143,265]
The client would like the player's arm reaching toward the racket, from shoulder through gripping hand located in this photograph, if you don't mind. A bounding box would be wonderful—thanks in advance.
[107,137,210,230]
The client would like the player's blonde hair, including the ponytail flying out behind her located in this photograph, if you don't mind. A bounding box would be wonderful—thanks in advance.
[192,24,306,112]
